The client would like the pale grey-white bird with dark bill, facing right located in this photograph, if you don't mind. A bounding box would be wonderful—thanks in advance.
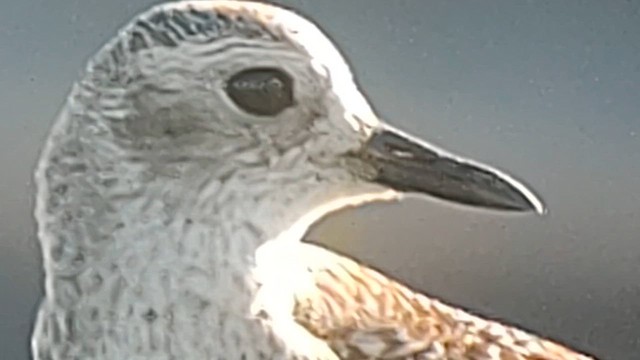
[31,0,592,360]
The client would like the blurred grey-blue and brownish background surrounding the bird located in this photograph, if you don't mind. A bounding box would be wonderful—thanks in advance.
[0,0,640,360]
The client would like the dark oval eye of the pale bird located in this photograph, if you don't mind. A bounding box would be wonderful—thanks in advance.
[226,68,293,116]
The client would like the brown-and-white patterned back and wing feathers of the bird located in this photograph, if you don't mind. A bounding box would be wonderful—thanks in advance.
[294,244,593,360]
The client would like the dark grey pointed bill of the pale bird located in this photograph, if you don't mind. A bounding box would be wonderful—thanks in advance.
[361,127,544,213]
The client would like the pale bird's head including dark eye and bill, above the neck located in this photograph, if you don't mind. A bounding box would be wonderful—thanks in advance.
[36,1,544,217]
